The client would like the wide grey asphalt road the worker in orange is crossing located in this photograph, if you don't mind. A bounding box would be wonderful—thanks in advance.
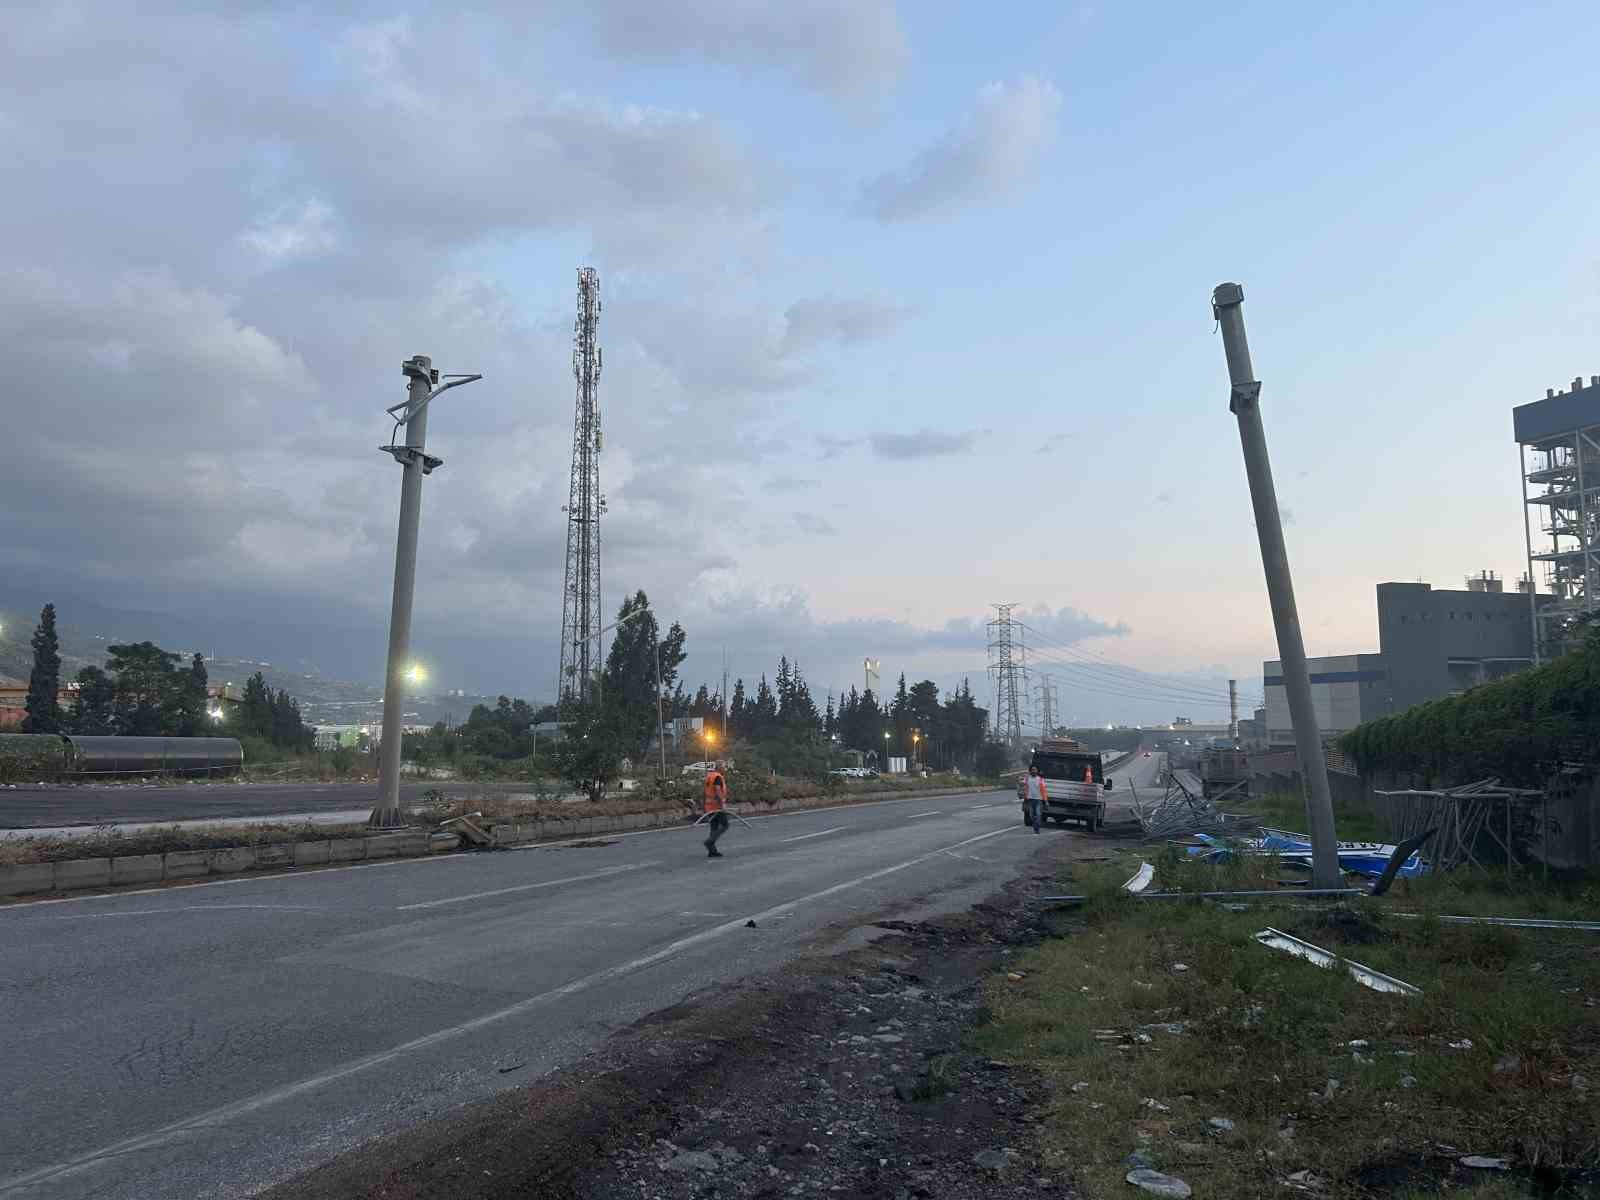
[0,758,1155,1200]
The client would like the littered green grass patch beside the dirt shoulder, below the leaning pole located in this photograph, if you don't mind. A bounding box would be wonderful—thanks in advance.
[973,859,1600,1198]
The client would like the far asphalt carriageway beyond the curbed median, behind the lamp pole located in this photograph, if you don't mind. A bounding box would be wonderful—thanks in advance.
[0,782,530,829]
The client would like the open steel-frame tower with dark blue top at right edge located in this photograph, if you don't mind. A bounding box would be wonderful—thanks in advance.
[1512,374,1600,662]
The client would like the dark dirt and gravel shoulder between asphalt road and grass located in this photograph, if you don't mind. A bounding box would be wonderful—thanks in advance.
[266,837,1099,1200]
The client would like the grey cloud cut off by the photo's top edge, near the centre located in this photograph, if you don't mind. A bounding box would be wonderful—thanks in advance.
[576,0,910,98]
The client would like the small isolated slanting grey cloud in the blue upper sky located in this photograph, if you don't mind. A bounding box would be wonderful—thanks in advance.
[862,75,1061,221]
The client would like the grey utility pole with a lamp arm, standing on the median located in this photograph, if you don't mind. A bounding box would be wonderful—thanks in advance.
[368,354,483,829]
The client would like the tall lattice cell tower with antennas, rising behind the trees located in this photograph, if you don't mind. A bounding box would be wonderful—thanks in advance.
[557,267,605,701]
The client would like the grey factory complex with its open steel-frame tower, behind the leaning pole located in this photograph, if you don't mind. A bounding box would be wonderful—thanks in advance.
[1261,376,1600,747]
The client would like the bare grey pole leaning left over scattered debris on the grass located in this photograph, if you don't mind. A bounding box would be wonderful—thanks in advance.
[1211,283,1341,888]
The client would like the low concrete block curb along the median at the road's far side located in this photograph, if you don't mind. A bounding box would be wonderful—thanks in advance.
[0,786,995,898]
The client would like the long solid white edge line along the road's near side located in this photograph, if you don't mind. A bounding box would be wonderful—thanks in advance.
[0,826,1018,1195]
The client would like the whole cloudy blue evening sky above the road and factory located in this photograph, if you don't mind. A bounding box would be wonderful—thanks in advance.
[0,0,1600,722]
